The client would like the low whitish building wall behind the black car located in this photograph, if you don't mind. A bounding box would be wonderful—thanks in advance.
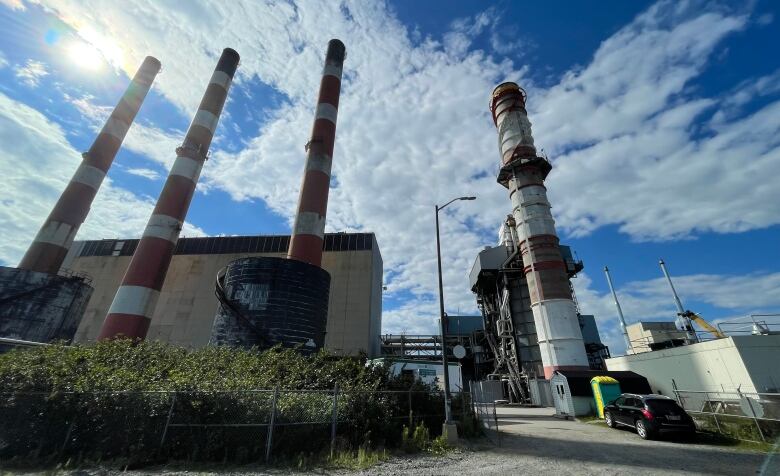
[606,335,780,397]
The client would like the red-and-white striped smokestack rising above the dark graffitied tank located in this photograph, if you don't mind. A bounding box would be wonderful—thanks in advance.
[287,40,346,266]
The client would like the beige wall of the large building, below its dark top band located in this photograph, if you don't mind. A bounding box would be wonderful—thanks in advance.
[67,236,382,355]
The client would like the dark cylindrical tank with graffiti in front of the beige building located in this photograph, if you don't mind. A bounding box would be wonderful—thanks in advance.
[210,257,330,354]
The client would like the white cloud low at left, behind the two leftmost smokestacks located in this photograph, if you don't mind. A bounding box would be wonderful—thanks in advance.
[0,94,203,265]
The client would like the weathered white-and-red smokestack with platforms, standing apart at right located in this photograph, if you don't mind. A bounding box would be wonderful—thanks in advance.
[490,83,588,379]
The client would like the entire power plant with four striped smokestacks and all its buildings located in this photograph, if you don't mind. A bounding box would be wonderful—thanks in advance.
[0,39,780,444]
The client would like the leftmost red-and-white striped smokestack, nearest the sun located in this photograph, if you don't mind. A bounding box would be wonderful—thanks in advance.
[18,56,160,274]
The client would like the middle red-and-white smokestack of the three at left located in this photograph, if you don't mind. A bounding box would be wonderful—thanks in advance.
[98,48,239,340]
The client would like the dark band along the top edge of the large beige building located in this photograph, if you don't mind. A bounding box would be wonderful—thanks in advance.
[73,233,376,256]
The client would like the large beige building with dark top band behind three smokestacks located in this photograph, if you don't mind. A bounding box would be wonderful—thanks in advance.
[65,233,383,356]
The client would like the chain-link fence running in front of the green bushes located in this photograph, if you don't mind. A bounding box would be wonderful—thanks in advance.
[0,388,476,462]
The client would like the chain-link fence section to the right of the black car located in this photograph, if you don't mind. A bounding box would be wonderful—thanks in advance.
[675,390,780,443]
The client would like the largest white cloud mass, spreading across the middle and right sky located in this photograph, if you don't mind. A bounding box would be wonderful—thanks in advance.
[21,0,780,338]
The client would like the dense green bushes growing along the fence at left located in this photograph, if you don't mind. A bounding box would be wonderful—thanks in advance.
[0,340,470,467]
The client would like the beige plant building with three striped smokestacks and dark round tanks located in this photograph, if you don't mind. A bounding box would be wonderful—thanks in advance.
[0,39,382,356]
